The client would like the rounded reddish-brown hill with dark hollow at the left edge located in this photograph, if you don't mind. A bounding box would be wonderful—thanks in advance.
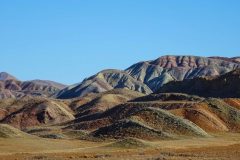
[0,97,74,129]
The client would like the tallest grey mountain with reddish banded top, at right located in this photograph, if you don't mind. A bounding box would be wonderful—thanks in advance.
[126,56,240,92]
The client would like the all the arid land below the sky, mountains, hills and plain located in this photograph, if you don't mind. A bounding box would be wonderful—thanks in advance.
[0,56,240,160]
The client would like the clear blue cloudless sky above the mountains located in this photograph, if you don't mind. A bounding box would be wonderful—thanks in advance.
[0,0,240,84]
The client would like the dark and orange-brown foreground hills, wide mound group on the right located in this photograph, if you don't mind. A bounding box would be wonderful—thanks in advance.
[63,93,240,140]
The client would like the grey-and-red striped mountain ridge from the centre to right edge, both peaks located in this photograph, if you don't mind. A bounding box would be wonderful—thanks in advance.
[56,56,240,99]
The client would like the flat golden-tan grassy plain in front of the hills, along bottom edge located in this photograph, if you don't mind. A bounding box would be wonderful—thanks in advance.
[0,133,240,160]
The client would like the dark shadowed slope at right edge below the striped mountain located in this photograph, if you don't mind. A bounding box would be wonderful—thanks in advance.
[159,69,240,98]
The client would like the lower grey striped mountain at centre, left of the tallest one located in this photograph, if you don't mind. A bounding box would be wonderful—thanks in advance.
[56,70,152,99]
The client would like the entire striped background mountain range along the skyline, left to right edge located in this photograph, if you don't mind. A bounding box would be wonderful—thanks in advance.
[0,56,240,99]
